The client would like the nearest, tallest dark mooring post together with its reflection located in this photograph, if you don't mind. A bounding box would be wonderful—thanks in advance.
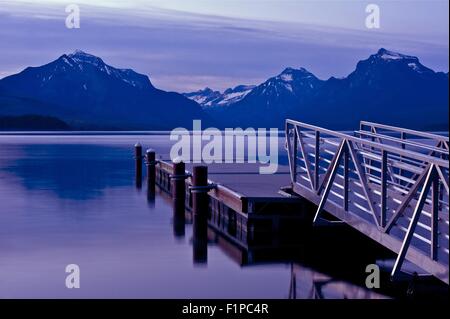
[191,166,209,264]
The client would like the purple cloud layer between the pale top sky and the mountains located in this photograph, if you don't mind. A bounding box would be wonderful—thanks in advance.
[0,1,448,91]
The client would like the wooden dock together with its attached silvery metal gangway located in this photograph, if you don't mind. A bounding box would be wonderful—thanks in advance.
[136,120,449,284]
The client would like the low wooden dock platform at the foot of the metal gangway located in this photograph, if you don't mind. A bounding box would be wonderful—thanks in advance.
[148,160,314,245]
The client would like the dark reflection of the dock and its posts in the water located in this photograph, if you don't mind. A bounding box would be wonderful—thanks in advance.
[155,178,446,299]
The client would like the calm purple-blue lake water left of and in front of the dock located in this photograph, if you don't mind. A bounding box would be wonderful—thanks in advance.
[0,135,388,298]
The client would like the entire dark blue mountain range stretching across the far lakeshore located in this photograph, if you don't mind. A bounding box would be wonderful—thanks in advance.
[0,49,449,130]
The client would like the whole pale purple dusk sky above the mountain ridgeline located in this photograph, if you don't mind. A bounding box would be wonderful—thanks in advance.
[0,0,449,92]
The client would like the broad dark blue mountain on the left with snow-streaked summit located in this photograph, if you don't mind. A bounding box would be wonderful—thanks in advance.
[0,50,205,129]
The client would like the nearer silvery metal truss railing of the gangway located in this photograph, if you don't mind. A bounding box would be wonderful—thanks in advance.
[286,120,449,283]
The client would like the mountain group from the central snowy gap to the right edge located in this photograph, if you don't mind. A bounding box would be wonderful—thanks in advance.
[184,49,449,130]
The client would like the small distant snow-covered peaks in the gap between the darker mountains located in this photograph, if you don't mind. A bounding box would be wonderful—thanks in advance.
[183,85,255,108]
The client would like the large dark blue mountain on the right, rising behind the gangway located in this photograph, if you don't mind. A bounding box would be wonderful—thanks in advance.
[304,48,449,129]
